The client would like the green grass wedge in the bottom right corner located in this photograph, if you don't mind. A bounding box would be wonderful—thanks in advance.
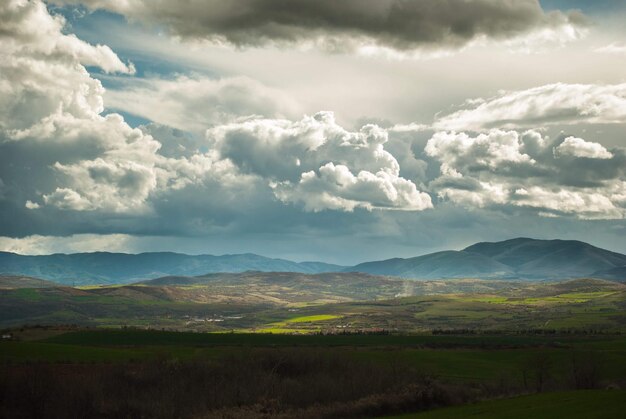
[388,390,626,419]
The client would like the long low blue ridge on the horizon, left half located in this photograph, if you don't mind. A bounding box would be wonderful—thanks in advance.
[0,252,343,285]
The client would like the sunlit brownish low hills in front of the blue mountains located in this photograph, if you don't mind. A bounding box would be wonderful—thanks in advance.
[134,272,521,304]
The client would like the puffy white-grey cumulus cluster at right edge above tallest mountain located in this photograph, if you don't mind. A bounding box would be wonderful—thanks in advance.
[425,130,626,219]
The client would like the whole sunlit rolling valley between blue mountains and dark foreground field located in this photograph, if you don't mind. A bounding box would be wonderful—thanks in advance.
[0,272,626,334]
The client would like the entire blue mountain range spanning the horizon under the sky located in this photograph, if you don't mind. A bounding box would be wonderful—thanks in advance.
[0,238,626,285]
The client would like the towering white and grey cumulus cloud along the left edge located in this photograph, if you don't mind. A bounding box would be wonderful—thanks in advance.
[0,0,228,217]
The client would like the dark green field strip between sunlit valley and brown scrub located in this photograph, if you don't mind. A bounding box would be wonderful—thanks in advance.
[0,330,626,385]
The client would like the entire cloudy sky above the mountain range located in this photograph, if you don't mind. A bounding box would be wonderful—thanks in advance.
[0,0,626,264]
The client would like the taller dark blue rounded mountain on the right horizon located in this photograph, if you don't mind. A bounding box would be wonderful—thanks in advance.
[346,238,626,280]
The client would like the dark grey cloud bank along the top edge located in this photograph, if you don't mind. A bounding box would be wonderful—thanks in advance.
[51,0,585,51]
